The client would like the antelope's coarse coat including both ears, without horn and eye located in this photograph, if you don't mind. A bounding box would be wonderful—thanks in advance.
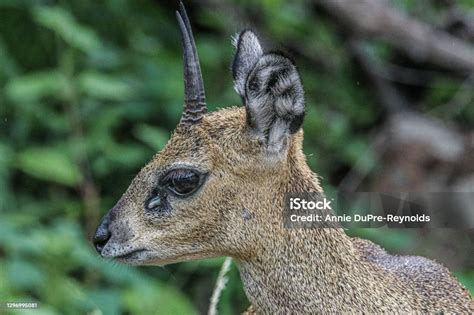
[93,11,474,314]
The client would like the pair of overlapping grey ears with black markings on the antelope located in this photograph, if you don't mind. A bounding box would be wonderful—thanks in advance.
[232,31,304,153]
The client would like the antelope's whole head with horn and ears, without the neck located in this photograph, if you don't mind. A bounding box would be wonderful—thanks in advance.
[94,4,306,265]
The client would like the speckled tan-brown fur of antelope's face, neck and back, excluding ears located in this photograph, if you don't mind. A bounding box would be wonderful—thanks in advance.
[99,108,472,314]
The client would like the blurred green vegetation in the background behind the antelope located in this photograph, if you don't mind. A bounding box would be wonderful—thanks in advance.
[0,0,474,314]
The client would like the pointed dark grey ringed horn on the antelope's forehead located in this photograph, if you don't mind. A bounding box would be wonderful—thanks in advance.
[176,2,207,125]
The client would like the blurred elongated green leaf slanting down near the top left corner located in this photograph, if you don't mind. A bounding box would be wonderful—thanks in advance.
[32,6,102,53]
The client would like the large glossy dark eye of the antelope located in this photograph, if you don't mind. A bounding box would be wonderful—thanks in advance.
[164,169,203,196]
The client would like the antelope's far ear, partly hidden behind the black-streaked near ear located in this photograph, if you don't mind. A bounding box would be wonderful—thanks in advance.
[232,30,263,97]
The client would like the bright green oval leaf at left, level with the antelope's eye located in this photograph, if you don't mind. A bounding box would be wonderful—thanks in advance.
[16,148,81,186]
